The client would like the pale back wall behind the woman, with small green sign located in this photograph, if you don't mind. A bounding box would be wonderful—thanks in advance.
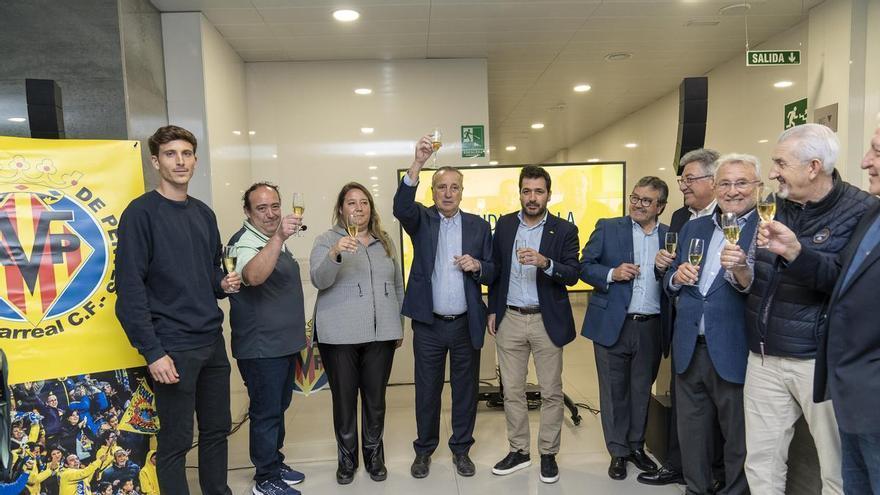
[246,60,495,383]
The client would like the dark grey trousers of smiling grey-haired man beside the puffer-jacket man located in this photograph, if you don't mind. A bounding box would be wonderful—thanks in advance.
[675,342,749,495]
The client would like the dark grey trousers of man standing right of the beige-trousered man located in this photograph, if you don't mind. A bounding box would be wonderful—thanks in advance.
[593,318,661,457]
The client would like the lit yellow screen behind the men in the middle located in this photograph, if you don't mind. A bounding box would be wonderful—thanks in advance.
[398,162,626,291]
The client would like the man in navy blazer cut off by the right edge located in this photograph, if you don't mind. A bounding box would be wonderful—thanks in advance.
[758,127,880,493]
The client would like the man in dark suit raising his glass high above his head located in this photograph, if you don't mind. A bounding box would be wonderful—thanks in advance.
[394,136,495,478]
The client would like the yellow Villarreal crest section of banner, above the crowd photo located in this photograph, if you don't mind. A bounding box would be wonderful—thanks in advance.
[0,137,144,383]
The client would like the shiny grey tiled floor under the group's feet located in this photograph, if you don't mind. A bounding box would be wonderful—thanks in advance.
[182,332,683,495]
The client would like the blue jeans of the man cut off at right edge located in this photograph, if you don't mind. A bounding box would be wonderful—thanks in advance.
[840,430,880,495]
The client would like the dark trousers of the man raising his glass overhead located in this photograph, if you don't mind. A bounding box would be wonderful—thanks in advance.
[412,317,480,455]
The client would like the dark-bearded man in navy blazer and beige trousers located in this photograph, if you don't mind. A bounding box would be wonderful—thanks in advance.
[488,165,579,483]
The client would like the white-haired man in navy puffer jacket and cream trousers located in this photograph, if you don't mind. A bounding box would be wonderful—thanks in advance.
[744,124,876,495]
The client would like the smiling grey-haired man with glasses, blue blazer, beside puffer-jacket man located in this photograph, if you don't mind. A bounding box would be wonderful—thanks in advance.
[663,154,760,495]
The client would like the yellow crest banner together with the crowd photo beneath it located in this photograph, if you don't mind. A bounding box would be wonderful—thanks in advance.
[0,137,158,493]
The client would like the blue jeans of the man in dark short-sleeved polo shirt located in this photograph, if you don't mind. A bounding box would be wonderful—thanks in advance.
[238,354,294,483]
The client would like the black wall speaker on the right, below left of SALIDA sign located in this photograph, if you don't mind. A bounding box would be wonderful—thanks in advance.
[673,77,709,174]
